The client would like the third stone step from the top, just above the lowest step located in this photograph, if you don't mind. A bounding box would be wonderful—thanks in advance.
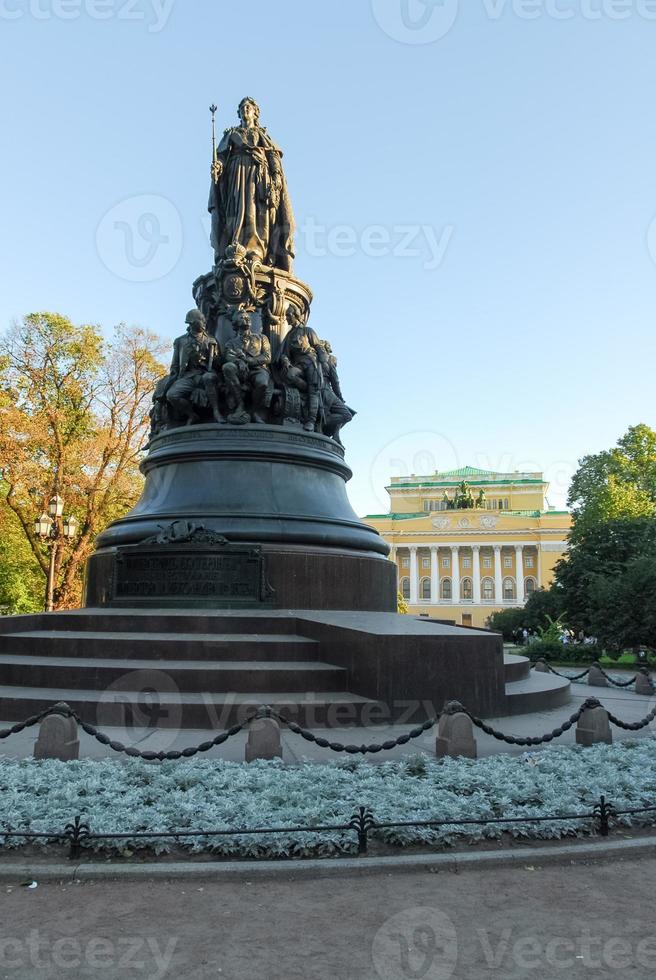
[0,654,348,696]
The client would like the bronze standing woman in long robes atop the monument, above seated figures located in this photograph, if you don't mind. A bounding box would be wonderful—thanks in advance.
[208,98,294,272]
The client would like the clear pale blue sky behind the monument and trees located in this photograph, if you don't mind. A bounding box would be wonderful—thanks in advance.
[0,0,656,513]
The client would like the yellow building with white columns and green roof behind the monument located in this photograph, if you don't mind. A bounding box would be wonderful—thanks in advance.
[365,466,571,626]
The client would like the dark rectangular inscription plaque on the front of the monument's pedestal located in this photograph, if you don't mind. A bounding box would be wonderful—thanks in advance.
[113,544,273,608]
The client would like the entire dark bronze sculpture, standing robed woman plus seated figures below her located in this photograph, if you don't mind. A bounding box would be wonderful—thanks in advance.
[151,98,355,444]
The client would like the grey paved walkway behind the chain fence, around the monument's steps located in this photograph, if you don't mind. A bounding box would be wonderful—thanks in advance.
[0,671,656,763]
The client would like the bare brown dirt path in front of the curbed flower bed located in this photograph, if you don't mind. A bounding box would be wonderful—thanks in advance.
[0,856,656,980]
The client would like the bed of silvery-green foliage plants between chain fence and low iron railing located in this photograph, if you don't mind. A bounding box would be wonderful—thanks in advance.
[0,738,656,857]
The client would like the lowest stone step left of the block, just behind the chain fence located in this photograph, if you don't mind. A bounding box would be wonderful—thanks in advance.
[0,686,384,728]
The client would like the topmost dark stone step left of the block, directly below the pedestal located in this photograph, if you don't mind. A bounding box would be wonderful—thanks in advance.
[0,609,296,636]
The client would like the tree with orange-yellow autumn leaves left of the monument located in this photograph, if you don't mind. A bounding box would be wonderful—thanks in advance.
[0,313,164,608]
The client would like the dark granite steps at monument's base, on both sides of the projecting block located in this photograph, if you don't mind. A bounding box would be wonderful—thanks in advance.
[0,609,569,731]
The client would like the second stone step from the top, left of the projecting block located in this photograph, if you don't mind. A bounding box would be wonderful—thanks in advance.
[0,630,319,661]
